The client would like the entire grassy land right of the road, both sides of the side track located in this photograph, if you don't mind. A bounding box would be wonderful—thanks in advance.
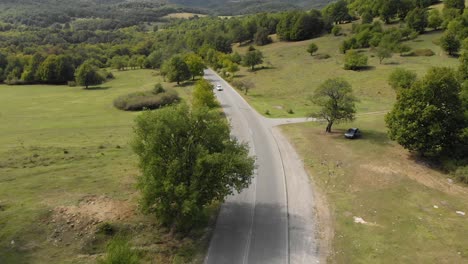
[231,21,468,263]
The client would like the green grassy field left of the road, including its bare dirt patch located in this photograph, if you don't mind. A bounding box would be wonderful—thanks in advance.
[0,70,207,263]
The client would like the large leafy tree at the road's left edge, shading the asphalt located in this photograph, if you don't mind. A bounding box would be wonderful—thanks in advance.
[133,104,254,230]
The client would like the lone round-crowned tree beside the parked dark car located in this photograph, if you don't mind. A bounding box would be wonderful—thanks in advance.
[311,78,357,133]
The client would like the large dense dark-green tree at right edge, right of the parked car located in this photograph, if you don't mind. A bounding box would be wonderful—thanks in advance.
[385,68,463,156]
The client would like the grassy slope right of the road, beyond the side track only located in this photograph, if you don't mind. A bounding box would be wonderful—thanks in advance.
[235,24,458,117]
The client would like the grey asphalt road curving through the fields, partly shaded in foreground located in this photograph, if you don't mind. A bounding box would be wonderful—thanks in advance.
[205,70,319,264]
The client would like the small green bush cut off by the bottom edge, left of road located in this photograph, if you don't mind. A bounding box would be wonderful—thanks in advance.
[98,237,140,264]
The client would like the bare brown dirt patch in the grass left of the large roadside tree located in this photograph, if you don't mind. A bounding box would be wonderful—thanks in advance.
[48,196,135,246]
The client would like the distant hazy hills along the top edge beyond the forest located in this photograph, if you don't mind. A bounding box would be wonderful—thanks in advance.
[0,0,334,29]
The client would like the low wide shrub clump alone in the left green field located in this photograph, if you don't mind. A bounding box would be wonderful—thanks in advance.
[114,90,180,111]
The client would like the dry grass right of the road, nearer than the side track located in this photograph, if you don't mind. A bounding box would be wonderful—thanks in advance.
[283,118,468,263]
